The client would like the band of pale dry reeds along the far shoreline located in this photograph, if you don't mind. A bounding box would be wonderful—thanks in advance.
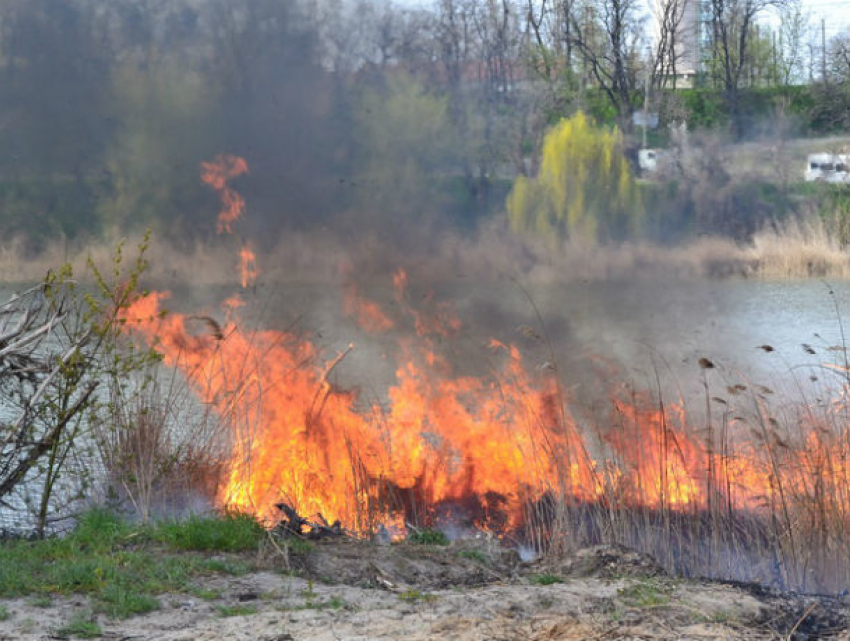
[0,216,850,287]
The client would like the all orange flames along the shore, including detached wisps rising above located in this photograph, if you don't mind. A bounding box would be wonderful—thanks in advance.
[127,156,847,535]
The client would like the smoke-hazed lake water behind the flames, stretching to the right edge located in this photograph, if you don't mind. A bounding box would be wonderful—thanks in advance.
[159,272,850,410]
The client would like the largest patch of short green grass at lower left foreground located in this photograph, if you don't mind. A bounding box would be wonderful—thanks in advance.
[0,510,263,618]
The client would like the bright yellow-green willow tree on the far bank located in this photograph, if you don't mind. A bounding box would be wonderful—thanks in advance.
[507,112,642,241]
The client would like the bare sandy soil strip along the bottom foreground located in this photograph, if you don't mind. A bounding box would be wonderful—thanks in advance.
[0,546,850,641]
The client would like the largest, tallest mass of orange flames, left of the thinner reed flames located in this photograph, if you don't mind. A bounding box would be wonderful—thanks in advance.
[122,286,583,530]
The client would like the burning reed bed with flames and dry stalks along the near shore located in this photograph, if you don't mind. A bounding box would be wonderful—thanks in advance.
[112,262,850,592]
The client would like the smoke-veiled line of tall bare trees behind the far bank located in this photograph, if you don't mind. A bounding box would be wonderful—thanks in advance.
[0,0,850,250]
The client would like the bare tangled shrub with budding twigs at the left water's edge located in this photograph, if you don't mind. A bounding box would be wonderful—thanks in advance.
[0,238,154,534]
